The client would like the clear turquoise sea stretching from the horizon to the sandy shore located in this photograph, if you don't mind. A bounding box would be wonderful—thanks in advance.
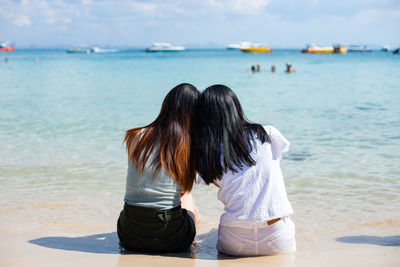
[0,50,400,232]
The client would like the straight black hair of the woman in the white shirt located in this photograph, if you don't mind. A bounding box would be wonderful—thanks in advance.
[192,84,270,184]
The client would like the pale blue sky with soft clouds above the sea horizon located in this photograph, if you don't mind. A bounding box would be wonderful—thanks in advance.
[0,0,400,48]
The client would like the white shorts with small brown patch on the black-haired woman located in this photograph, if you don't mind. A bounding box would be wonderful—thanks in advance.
[217,217,296,256]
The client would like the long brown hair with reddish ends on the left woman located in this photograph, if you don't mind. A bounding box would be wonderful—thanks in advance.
[124,83,200,192]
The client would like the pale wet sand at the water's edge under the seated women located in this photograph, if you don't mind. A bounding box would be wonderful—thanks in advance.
[0,217,400,267]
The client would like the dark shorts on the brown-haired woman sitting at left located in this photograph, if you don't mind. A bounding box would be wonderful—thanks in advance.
[117,203,196,253]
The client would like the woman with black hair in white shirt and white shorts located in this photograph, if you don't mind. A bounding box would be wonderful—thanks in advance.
[192,85,296,256]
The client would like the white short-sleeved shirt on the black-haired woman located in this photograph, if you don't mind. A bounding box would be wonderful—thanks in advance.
[198,126,293,226]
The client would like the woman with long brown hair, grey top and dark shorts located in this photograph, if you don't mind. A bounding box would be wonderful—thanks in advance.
[117,83,199,252]
